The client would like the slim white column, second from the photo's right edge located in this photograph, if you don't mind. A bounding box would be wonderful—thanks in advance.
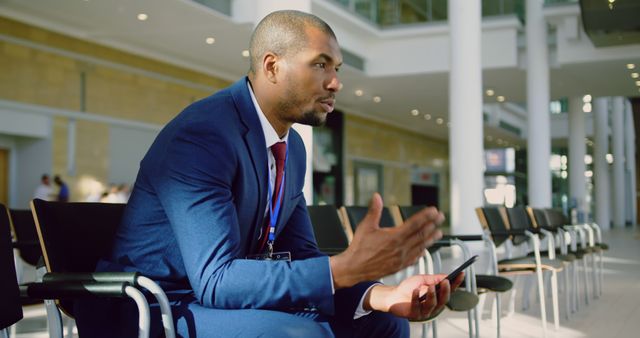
[611,96,626,227]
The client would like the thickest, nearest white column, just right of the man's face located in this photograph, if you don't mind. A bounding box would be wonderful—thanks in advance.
[448,0,484,234]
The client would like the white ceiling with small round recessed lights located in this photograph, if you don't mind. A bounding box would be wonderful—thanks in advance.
[0,0,640,145]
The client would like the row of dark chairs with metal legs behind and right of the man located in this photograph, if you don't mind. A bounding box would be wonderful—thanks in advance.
[309,206,607,337]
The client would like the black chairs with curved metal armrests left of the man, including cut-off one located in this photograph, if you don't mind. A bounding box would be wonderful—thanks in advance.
[0,199,175,338]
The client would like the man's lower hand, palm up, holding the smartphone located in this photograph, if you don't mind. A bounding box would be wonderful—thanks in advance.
[364,273,464,321]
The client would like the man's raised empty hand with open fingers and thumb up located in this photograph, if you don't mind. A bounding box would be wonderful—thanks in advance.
[330,193,444,289]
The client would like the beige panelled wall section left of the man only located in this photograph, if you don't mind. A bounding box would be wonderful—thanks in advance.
[0,17,229,200]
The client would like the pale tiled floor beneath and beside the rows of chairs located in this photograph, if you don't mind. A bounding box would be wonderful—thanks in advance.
[10,227,640,338]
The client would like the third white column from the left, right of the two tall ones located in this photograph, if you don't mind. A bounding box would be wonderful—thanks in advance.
[569,97,587,222]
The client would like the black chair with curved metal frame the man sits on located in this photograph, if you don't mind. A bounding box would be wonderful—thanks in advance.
[31,199,175,338]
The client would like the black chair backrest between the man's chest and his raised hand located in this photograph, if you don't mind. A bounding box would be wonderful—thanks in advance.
[307,205,349,255]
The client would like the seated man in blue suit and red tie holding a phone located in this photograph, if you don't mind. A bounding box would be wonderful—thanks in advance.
[76,11,461,337]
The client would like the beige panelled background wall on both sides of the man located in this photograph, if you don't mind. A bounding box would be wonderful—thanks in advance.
[0,17,448,208]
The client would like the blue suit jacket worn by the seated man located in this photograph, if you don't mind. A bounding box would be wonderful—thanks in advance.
[98,78,371,319]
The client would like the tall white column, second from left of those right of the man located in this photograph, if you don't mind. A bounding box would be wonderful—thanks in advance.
[528,0,551,208]
